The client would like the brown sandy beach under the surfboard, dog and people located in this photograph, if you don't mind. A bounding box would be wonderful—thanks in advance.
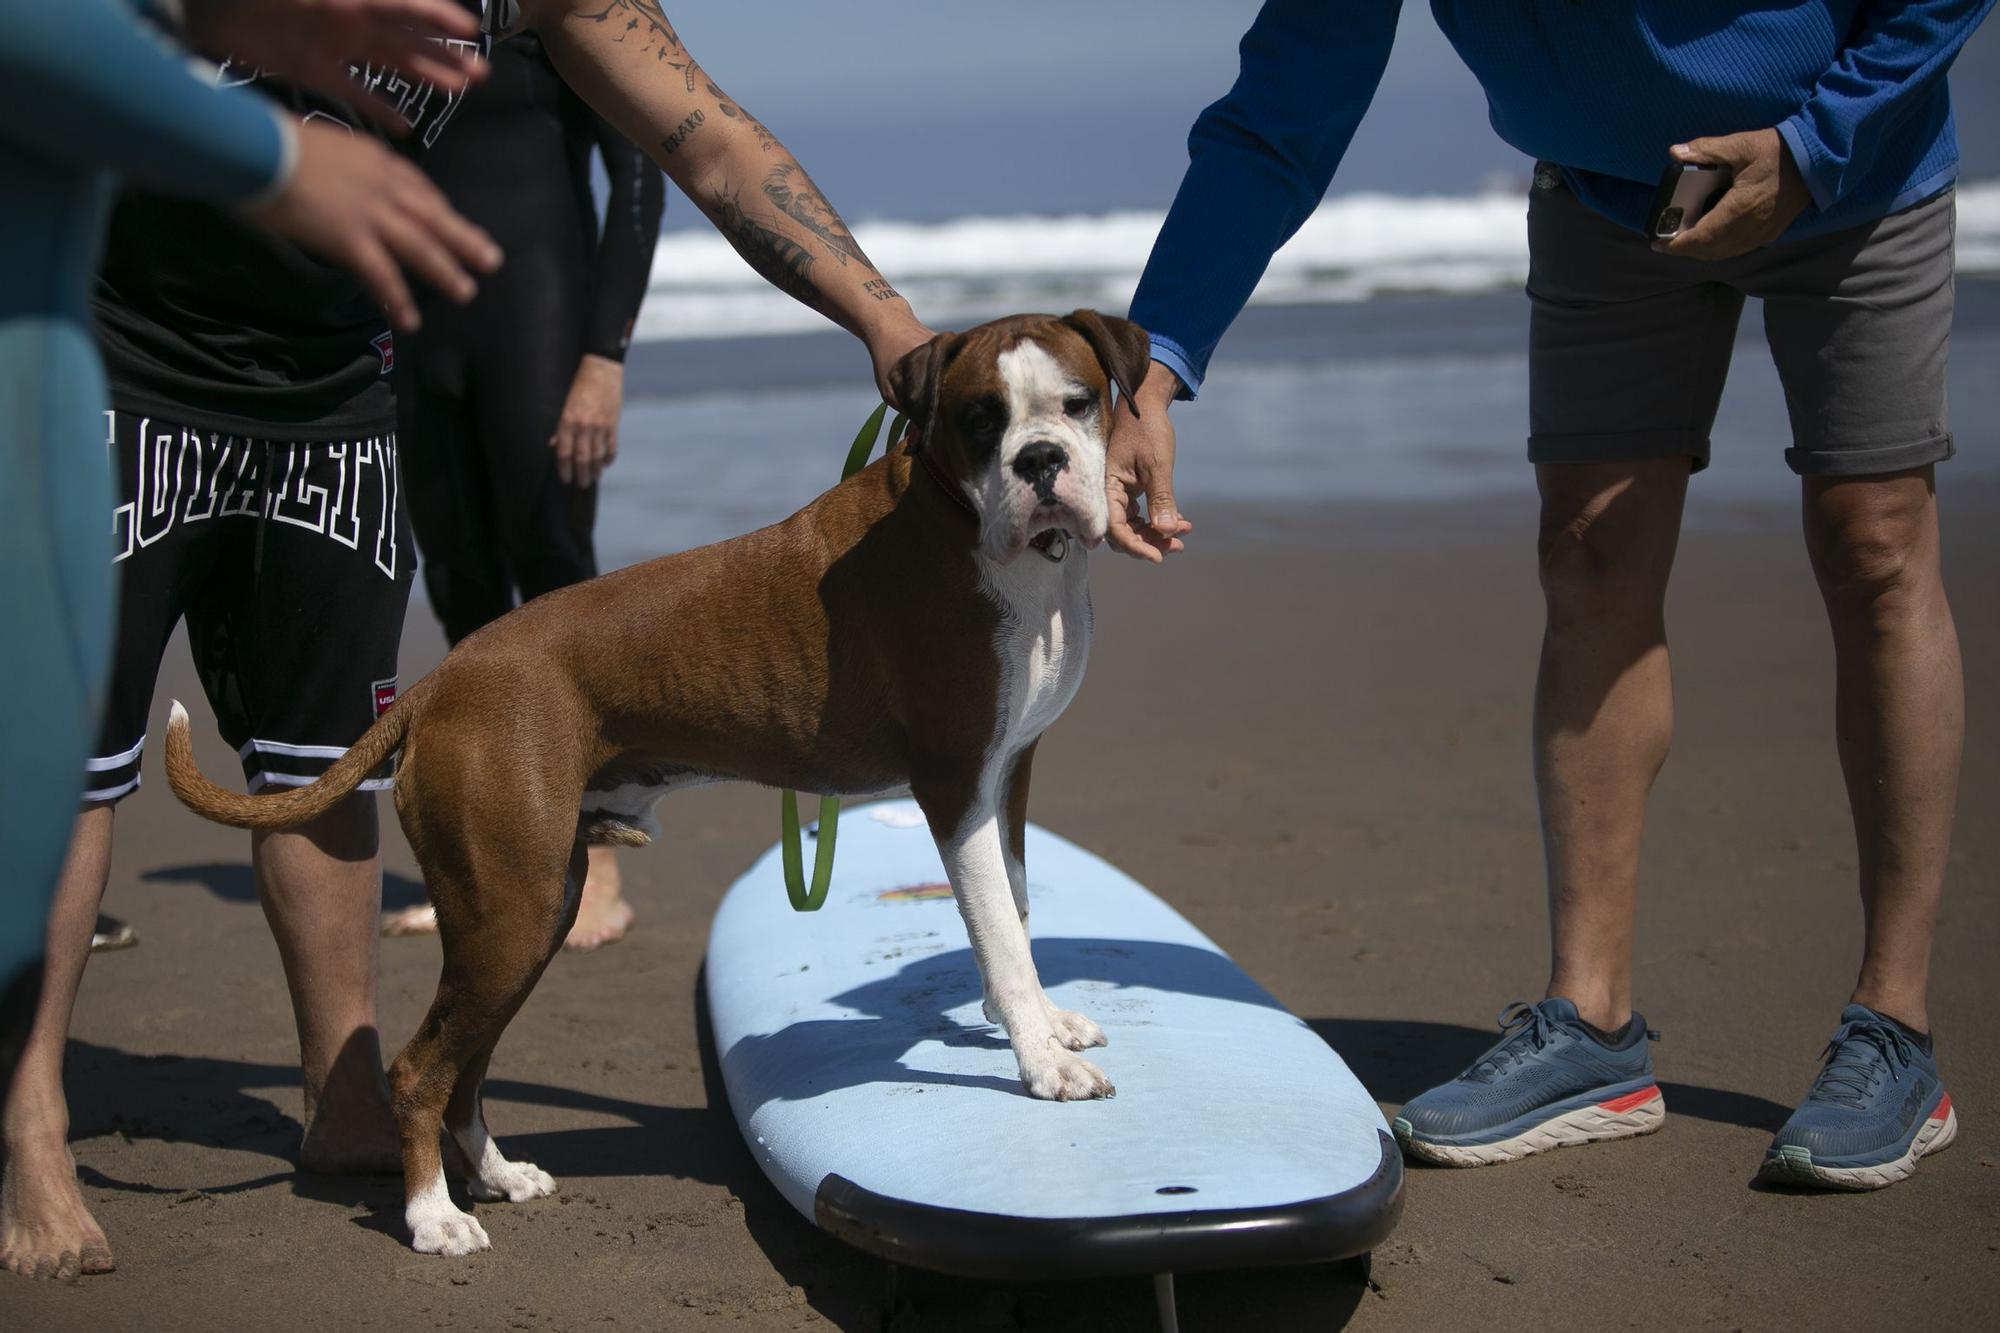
[0,466,2000,1331]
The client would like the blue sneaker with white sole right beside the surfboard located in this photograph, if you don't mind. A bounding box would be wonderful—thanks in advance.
[1392,999,1666,1167]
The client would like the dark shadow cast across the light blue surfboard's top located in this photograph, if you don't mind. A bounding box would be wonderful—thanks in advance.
[722,937,1280,1101]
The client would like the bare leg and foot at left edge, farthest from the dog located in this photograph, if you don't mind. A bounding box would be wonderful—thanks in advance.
[0,805,112,1279]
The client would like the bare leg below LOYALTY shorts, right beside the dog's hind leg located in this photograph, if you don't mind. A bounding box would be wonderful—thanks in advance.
[250,793,402,1173]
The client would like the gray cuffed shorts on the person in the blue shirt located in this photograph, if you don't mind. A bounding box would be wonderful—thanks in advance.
[1528,170,1956,476]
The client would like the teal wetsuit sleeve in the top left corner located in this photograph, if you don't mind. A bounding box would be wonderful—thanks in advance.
[0,0,294,202]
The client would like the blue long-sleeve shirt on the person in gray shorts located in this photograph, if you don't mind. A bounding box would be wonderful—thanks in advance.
[1132,0,1994,396]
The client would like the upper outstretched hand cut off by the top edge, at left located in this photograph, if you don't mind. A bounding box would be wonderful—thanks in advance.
[186,0,486,134]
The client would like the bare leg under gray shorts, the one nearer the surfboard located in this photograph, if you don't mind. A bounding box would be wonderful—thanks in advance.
[1534,458,1688,1029]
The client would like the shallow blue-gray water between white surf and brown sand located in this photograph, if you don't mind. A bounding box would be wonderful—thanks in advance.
[598,280,2000,566]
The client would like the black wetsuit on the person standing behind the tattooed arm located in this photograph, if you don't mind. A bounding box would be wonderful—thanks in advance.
[396,36,666,642]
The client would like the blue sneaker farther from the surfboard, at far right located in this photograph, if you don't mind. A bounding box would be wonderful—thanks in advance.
[1758,1005,1958,1189]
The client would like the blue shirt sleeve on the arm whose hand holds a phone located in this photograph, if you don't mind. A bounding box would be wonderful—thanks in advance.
[1778,0,1994,212]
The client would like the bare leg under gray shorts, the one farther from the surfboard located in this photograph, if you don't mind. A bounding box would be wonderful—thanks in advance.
[1804,466,1966,1031]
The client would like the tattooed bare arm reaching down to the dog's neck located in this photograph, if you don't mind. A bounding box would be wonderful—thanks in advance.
[522,0,930,396]
